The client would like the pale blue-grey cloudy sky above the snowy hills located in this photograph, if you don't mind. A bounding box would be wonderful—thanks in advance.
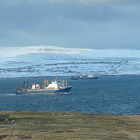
[0,0,140,49]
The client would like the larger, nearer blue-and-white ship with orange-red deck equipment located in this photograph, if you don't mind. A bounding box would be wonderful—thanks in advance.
[15,78,72,95]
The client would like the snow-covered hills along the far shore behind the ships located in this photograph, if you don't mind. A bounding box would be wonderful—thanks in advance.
[0,46,140,78]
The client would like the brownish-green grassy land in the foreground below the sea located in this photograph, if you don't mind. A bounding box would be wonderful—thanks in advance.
[0,111,140,140]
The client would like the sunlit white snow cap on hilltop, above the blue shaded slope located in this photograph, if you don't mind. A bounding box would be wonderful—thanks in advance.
[0,46,91,58]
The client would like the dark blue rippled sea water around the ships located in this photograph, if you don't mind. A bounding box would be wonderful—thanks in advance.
[0,76,140,114]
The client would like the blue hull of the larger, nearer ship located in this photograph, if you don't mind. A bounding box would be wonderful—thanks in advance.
[15,86,72,95]
